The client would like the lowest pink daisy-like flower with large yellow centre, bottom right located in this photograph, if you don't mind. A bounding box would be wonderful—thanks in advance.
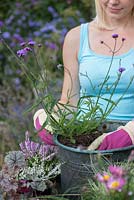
[106,177,126,191]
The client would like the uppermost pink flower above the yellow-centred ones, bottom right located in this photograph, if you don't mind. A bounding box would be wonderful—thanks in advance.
[108,165,126,177]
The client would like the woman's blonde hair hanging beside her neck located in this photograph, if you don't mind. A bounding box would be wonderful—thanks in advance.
[95,0,134,30]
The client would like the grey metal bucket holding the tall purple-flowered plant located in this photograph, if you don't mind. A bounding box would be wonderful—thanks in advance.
[54,126,134,193]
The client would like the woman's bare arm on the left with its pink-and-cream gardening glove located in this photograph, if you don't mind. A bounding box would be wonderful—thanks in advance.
[34,27,80,144]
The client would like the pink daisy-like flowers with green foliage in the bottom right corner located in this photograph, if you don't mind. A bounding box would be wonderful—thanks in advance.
[83,158,134,200]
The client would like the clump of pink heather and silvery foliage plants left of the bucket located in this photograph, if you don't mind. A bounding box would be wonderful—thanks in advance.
[0,131,60,198]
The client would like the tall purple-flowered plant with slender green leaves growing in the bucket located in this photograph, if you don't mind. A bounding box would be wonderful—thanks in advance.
[3,34,134,143]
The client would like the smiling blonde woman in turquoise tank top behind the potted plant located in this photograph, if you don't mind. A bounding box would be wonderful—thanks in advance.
[33,0,134,149]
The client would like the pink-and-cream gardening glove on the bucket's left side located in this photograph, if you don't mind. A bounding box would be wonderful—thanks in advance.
[34,109,55,145]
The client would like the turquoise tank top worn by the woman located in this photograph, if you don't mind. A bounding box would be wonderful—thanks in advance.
[78,23,134,121]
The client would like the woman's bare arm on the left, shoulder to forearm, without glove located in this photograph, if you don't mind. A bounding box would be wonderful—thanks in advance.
[59,26,80,106]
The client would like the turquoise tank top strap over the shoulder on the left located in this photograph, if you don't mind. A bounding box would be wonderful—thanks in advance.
[78,23,89,61]
